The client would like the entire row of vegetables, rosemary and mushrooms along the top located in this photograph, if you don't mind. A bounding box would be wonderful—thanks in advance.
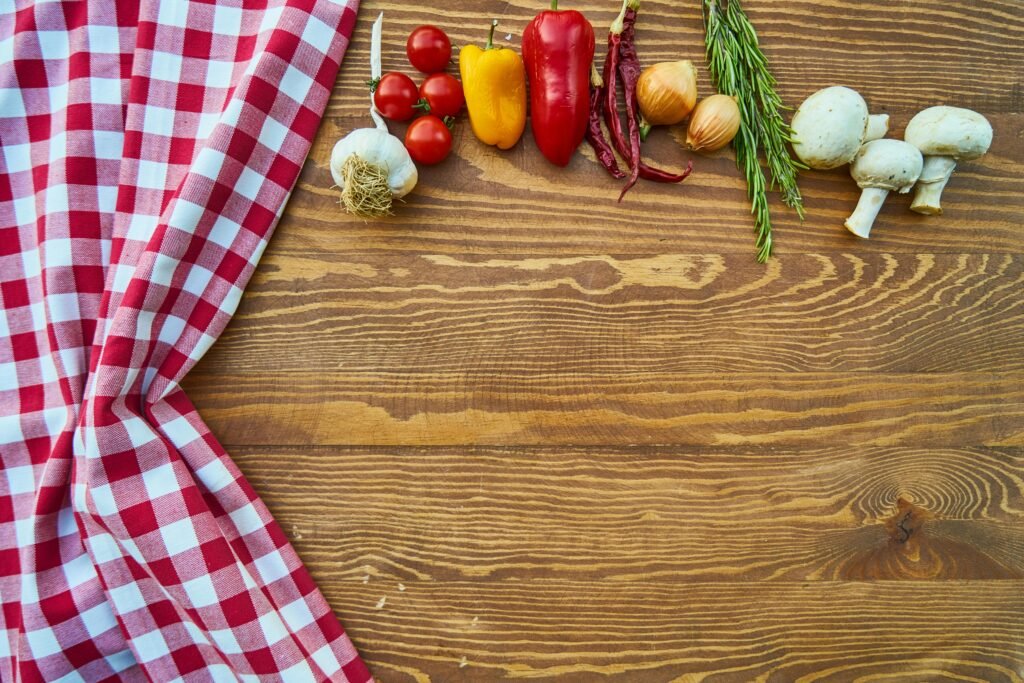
[331,0,992,262]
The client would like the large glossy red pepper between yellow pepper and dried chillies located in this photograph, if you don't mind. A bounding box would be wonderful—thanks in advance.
[522,0,594,166]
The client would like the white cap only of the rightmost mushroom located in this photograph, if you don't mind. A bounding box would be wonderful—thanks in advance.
[903,106,992,161]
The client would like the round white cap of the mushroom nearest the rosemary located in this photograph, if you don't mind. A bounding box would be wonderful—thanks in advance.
[792,85,867,169]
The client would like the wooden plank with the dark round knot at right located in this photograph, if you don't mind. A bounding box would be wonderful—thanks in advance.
[234,446,1024,583]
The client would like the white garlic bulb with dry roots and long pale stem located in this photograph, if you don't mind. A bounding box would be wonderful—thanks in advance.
[331,12,419,218]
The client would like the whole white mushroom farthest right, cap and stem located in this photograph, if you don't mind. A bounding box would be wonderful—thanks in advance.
[903,106,992,216]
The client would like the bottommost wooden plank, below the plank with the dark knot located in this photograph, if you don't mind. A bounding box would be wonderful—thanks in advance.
[322,580,1024,683]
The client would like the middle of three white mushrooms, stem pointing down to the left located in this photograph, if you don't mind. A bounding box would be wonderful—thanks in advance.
[846,140,925,240]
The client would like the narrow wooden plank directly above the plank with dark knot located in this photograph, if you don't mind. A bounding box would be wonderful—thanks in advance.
[187,372,1024,446]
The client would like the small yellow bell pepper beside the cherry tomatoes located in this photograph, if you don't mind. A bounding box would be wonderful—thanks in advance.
[459,19,526,150]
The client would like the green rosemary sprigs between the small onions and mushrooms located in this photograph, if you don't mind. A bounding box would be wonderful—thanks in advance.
[700,0,806,263]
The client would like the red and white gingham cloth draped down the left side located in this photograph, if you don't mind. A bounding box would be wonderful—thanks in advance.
[0,0,370,683]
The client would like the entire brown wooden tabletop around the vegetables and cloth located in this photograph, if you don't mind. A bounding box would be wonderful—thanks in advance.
[187,0,1024,682]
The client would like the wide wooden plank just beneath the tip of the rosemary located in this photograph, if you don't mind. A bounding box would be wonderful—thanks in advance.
[197,253,1024,375]
